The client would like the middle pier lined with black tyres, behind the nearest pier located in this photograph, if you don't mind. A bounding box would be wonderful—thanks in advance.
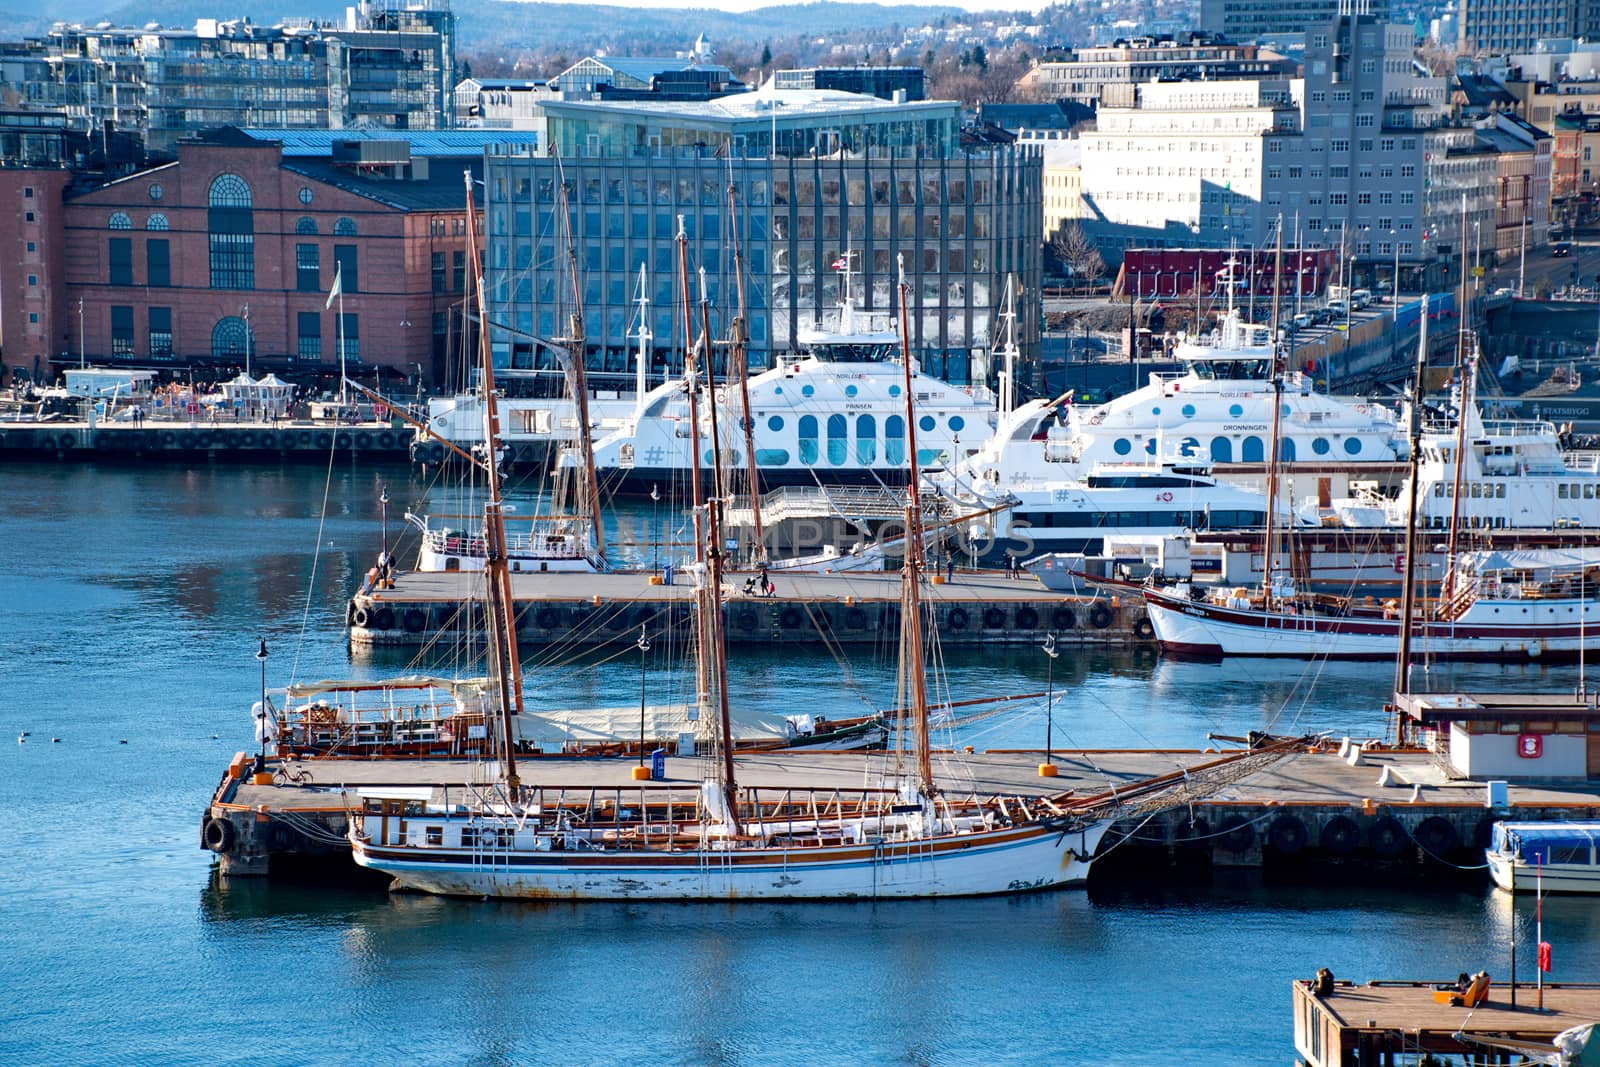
[346,569,1155,648]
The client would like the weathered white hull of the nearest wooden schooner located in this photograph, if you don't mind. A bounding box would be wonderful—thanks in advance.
[354,821,1109,901]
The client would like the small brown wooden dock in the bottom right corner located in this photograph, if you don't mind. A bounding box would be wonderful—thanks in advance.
[1294,979,1600,1067]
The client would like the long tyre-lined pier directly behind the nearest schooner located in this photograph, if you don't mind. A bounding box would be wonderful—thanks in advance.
[202,749,1600,883]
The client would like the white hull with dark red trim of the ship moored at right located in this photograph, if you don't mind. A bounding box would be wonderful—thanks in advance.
[1146,592,1600,661]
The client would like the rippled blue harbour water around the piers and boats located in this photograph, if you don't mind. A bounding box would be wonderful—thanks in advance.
[0,466,1600,1065]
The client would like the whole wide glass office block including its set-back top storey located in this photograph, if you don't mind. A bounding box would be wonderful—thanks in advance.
[486,90,1043,382]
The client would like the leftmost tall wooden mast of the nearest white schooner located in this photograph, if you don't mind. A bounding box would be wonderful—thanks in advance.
[466,171,523,797]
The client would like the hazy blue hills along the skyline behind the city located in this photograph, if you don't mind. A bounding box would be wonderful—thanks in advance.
[0,0,973,48]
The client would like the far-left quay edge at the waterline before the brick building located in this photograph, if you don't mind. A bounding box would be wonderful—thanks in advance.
[0,418,413,461]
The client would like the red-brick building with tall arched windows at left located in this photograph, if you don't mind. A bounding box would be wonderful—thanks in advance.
[0,130,540,384]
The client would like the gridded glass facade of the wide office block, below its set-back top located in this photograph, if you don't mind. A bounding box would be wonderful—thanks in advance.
[486,144,1043,388]
